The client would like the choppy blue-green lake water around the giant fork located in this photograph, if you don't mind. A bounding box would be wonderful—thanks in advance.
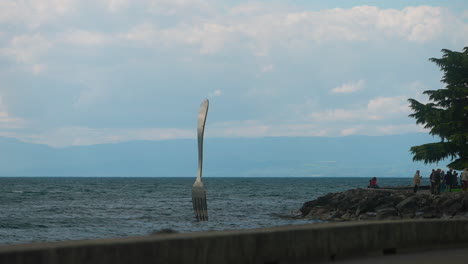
[0,177,420,244]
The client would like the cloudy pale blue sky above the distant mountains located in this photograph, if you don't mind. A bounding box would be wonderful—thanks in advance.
[0,0,468,147]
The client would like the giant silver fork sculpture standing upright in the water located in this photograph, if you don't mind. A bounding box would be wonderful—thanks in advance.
[192,99,208,221]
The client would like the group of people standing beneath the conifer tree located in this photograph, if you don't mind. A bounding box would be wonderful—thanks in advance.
[413,168,468,194]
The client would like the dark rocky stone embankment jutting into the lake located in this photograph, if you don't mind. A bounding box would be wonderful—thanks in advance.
[300,188,468,221]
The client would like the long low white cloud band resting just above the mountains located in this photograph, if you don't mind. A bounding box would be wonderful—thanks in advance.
[4,121,427,147]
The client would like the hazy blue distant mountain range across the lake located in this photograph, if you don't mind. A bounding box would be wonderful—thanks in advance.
[0,133,448,177]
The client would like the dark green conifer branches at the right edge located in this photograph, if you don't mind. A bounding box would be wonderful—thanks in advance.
[408,47,468,170]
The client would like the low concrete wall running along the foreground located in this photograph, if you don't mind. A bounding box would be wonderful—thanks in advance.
[0,220,468,264]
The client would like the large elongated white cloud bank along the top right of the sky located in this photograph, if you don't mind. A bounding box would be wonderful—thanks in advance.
[111,4,468,57]
